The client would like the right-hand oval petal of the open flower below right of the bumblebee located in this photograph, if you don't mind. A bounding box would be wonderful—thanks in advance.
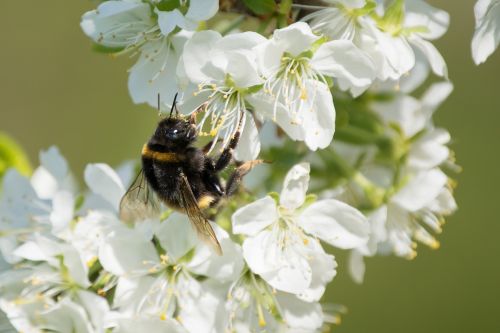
[299,199,369,249]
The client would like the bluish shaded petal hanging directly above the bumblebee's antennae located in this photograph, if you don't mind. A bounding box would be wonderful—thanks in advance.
[128,38,179,107]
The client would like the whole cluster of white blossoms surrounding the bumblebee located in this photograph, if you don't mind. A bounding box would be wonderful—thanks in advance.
[0,0,476,333]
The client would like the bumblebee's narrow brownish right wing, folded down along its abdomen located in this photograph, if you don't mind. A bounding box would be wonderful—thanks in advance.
[180,173,222,255]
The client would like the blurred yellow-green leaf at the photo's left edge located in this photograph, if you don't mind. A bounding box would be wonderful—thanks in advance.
[0,132,32,178]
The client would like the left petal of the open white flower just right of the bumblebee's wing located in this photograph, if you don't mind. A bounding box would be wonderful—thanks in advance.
[232,196,279,236]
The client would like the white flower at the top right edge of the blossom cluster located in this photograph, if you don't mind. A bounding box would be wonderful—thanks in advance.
[305,0,449,81]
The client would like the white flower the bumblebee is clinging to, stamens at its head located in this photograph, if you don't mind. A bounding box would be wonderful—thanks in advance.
[179,31,265,160]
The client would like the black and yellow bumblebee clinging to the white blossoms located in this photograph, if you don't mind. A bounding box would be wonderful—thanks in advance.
[120,96,262,255]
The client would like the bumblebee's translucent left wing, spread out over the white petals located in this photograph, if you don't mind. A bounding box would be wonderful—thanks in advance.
[120,169,161,223]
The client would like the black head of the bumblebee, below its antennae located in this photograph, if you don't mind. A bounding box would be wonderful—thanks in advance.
[151,117,197,148]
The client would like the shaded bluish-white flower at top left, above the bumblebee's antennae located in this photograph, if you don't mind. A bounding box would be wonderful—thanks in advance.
[81,0,195,106]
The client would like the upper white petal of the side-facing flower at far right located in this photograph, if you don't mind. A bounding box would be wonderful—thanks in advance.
[392,169,448,212]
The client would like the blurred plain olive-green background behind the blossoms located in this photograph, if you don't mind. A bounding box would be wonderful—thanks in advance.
[0,0,500,333]
